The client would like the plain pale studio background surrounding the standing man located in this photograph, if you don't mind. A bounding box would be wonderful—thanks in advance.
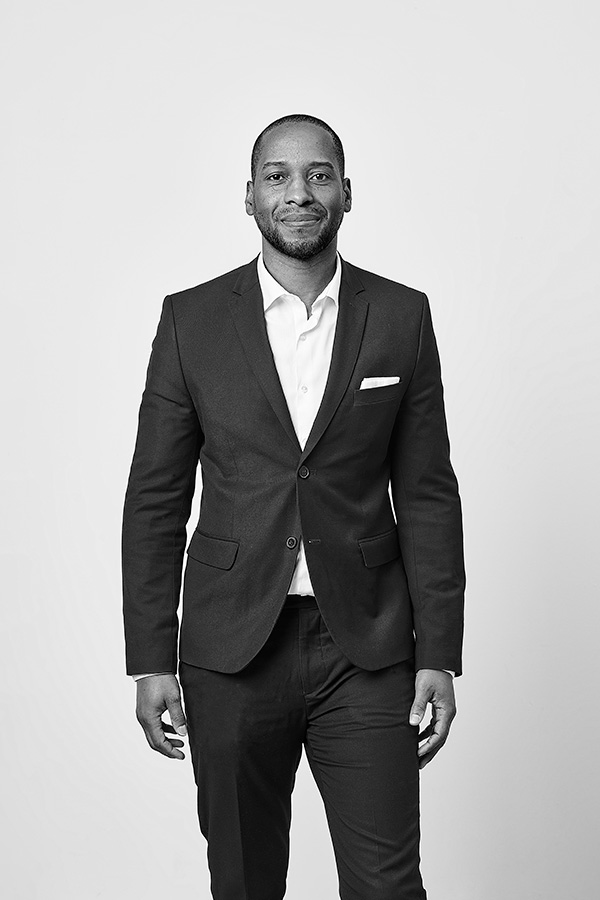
[0,0,600,900]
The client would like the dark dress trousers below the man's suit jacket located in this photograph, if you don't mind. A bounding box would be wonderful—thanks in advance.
[180,596,426,900]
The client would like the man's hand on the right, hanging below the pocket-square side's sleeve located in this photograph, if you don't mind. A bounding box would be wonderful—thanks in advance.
[409,669,456,769]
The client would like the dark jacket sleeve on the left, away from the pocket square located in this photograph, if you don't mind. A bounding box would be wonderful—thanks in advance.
[122,297,202,675]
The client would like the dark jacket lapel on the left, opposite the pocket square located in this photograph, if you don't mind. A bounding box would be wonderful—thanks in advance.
[229,260,300,451]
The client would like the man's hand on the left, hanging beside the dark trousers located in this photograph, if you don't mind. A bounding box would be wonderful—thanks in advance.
[135,675,187,759]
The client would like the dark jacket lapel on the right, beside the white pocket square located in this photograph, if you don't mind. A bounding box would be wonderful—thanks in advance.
[301,261,369,460]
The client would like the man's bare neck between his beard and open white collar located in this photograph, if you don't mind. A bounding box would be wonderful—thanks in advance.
[262,238,337,313]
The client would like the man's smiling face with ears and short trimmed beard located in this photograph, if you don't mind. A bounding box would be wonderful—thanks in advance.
[246,122,352,260]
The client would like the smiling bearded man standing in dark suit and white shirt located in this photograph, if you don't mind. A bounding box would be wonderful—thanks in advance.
[123,116,464,900]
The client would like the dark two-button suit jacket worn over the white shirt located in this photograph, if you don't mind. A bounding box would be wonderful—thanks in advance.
[123,261,464,674]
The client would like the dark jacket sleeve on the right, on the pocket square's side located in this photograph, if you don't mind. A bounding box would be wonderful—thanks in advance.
[391,295,465,675]
